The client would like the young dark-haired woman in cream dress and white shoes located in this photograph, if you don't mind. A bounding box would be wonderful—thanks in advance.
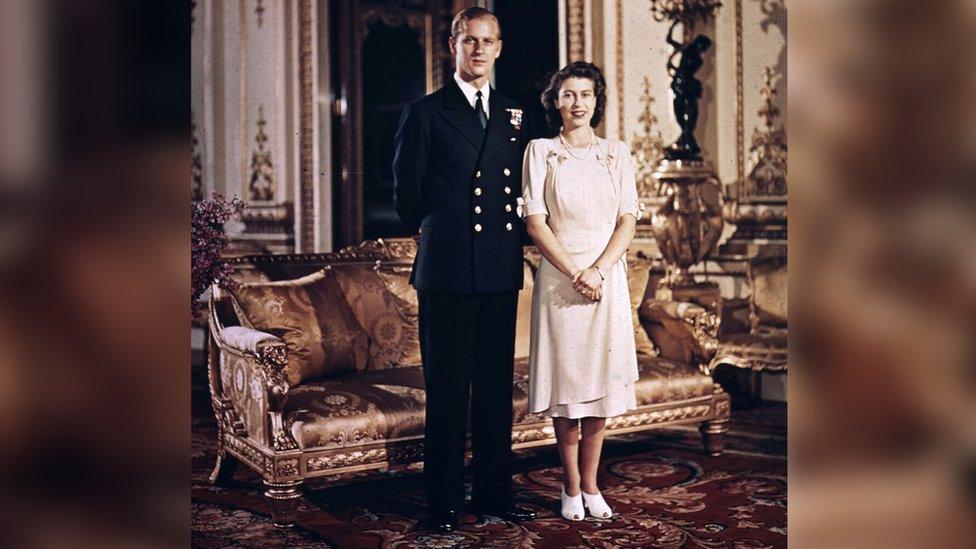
[522,62,641,520]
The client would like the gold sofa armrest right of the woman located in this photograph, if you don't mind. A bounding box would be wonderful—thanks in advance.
[638,298,720,374]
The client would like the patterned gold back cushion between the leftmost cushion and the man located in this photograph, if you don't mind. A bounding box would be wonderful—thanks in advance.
[332,264,420,369]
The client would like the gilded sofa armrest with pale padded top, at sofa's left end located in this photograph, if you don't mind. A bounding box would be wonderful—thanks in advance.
[210,288,298,451]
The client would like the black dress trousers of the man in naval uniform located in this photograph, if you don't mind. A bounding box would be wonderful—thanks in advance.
[417,291,518,511]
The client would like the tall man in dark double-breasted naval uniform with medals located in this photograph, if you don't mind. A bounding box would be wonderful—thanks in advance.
[393,8,535,532]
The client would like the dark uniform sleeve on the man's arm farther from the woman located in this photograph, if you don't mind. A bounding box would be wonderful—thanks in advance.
[393,104,430,233]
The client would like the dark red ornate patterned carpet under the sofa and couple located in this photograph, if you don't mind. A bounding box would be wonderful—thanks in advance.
[191,374,786,548]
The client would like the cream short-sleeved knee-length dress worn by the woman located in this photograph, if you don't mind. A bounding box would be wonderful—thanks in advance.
[522,137,641,418]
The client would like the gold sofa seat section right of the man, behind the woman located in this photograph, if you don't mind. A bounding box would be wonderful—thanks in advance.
[512,355,713,423]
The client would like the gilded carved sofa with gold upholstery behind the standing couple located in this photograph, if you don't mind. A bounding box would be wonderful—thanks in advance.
[208,239,729,526]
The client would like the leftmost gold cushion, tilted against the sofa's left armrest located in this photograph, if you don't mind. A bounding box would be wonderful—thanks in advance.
[233,269,368,385]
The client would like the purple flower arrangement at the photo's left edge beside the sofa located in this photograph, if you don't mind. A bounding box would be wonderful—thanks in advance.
[190,192,244,315]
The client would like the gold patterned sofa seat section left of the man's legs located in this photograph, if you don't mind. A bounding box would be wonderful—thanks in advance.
[284,367,425,448]
